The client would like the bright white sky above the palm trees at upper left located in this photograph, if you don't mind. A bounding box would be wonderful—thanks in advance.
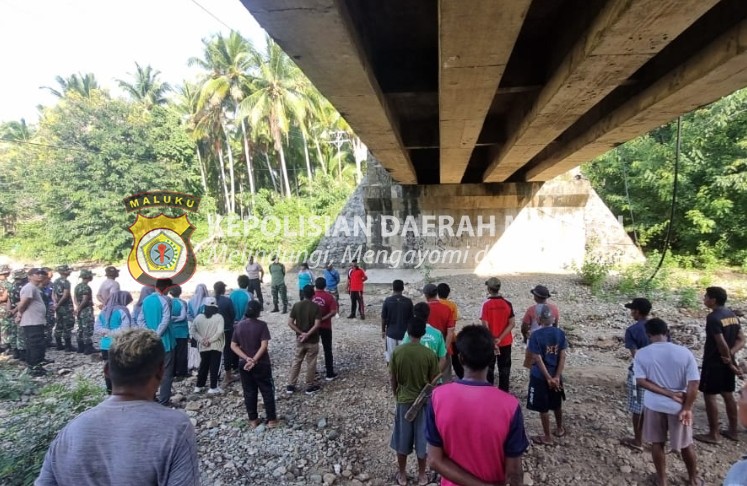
[0,0,265,123]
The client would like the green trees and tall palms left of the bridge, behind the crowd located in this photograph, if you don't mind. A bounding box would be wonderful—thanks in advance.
[0,32,366,265]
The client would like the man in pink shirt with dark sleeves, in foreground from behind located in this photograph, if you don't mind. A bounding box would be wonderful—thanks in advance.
[425,326,529,486]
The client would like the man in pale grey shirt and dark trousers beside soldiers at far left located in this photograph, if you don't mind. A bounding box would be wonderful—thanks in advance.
[16,268,47,376]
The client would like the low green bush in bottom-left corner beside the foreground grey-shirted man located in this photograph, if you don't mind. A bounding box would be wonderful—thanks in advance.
[0,380,105,486]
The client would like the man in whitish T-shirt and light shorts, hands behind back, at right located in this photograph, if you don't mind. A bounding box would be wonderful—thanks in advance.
[633,318,704,486]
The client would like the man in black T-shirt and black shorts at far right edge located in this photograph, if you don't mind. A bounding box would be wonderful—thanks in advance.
[693,287,744,444]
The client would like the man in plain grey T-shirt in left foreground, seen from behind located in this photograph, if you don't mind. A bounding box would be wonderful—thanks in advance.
[34,328,200,486]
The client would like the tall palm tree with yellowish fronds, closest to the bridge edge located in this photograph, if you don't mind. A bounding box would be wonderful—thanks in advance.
[238,37,308,196]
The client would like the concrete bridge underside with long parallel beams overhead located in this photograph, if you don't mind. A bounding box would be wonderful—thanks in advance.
[242,0,747,185]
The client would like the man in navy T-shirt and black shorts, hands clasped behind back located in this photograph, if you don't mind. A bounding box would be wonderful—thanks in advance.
[527,304,568,445]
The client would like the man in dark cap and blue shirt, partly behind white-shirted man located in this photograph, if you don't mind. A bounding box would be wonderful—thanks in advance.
[620,297,651,451]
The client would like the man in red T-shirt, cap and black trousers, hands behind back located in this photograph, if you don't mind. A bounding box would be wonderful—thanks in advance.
[480,277,515,392]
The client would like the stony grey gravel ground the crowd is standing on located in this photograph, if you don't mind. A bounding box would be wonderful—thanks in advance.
[5,275,747,486]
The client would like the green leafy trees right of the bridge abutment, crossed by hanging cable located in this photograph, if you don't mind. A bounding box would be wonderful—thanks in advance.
[582,90,747,269]
